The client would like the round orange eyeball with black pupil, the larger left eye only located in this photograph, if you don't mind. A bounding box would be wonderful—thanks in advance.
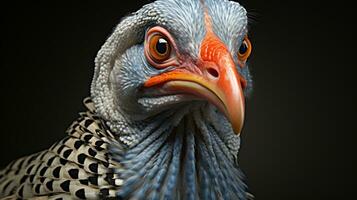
[149,34,171,62]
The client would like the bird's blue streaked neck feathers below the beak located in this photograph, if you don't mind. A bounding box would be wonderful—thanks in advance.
[107,106,246,199]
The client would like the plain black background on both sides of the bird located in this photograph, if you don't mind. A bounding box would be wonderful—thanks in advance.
[0,0,357,199]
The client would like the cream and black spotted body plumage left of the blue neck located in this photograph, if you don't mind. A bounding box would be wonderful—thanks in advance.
[0,98,122,199]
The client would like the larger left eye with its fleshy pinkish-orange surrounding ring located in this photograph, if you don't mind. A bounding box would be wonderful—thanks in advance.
[144,26,179,69]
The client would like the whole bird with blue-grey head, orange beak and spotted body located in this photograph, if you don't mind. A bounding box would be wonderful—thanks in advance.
[0,0,254,200]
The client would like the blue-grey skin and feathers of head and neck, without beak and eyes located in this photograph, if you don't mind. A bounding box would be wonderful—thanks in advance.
[91,0,252,199]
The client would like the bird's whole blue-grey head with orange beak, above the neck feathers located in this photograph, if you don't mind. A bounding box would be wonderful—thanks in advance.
[91,0,252,137]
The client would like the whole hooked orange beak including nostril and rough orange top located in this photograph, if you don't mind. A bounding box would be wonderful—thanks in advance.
[144,34,245,134]
